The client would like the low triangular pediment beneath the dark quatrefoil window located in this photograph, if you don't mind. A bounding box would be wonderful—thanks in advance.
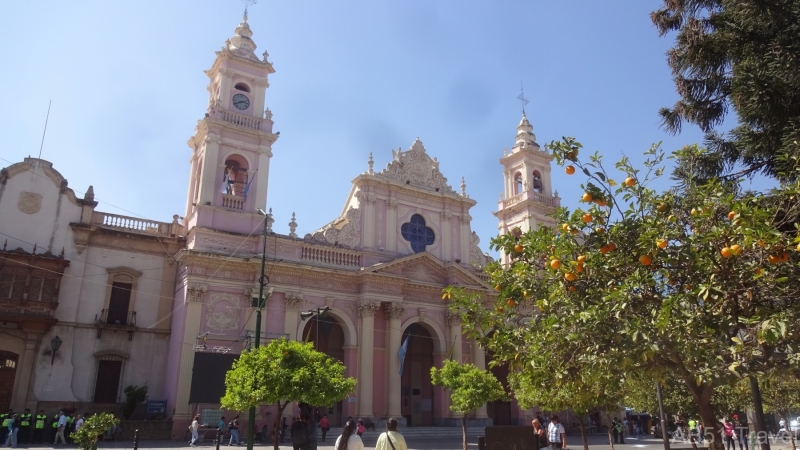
[364,252,486,288]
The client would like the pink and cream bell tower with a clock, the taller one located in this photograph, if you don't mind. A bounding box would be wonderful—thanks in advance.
[185,13,278,233]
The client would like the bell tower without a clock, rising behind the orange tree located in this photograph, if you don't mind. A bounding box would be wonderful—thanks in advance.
[494,111,561,250]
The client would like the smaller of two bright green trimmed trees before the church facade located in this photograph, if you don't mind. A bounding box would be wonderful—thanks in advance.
[431,359,506,450]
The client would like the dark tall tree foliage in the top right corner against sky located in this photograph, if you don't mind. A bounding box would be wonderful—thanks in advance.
[651,0,800,178]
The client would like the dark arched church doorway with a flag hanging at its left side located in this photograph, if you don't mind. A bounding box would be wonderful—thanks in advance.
[400,323,434,426]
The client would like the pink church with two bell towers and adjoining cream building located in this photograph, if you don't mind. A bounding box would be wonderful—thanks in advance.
[0,13,559,438]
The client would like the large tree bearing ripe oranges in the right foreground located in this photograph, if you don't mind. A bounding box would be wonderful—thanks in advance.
[444,138,800,445]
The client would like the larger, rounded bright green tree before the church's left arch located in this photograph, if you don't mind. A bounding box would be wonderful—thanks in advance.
[220,338,356,450]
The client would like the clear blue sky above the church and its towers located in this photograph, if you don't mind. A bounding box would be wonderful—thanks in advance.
[0,0,712,250]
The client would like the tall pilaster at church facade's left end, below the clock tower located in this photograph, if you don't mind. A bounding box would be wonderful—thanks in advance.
[173,284,208,419]
